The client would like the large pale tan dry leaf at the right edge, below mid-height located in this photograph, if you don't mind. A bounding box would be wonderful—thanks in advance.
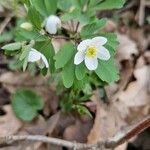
[118,65,150,107]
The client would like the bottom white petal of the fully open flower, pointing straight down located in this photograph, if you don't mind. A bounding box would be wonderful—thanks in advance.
[85,57,98,70]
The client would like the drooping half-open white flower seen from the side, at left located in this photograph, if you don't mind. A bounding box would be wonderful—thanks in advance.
[28,48,49,69]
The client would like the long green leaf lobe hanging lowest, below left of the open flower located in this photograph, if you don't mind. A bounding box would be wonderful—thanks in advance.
[62,59,75,88]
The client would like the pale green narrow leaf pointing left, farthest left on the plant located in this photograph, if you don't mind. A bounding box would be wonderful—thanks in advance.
[2,42,22,51]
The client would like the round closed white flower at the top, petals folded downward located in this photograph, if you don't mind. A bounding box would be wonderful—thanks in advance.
[45,15,61,34]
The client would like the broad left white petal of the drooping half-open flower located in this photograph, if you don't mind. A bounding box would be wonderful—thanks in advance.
[28,48,41,62]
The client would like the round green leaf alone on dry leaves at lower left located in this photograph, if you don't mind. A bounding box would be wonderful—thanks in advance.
[12,89,44,121]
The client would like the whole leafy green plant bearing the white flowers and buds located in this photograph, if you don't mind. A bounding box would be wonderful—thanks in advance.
[2,0,125,120]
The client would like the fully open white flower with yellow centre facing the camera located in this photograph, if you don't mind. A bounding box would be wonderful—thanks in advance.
[74,36,110,70]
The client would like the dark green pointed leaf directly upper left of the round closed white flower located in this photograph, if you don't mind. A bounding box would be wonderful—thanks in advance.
[28,6,42,30]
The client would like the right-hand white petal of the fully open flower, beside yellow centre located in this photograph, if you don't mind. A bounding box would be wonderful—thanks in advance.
[97,46,110,60]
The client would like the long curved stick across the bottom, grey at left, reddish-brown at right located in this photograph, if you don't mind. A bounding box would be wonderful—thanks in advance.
[0,116,150,150]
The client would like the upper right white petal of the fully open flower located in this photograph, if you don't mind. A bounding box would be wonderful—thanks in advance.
[91,36,107,48]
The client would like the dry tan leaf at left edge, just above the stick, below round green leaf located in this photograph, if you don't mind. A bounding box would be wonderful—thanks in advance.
[0,105,22,136]
